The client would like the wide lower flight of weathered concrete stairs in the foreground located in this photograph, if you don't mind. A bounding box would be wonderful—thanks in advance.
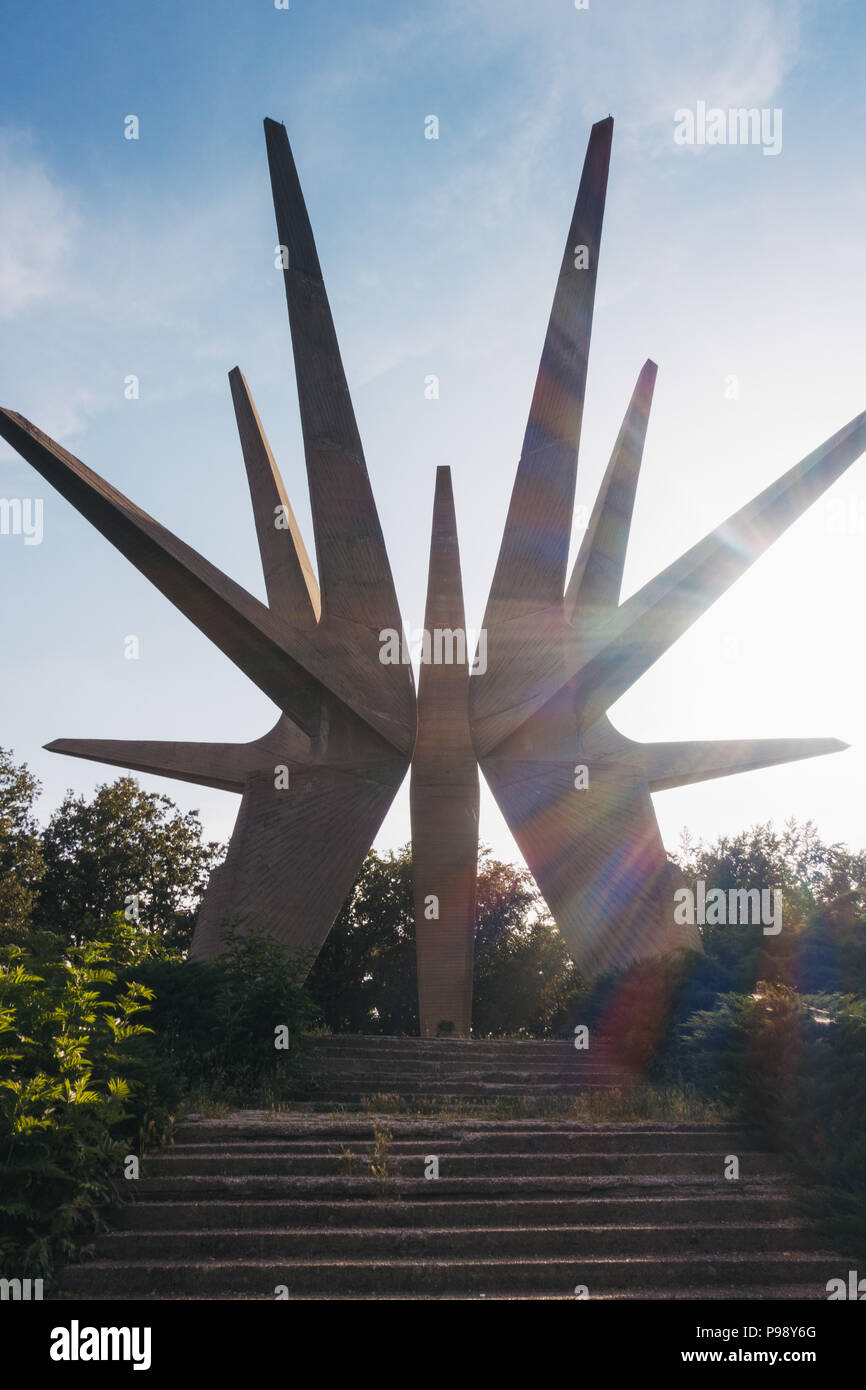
[55,1112,848,1300]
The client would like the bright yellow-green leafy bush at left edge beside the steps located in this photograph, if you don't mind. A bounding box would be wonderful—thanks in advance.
[0,933,150,1277]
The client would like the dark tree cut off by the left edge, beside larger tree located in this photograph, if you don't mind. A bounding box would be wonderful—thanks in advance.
[0,748,44,944]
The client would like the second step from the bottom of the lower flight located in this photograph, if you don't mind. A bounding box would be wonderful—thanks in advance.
[94,1218,820,1262]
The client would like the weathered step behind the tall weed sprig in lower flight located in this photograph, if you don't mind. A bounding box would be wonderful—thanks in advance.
[143,1145,780,1180]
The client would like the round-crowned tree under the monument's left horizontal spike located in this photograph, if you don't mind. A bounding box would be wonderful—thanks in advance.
[33,777,222,949]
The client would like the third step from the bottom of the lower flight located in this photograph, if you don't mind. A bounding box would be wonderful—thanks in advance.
[114,1191,792,1230]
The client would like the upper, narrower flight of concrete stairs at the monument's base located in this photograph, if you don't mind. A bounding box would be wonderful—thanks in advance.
[291,1034,635,1105]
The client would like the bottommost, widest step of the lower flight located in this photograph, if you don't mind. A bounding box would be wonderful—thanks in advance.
[63,1251,847,1298]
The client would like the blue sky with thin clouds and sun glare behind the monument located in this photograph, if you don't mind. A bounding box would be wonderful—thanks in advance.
[0,0,866,860]
